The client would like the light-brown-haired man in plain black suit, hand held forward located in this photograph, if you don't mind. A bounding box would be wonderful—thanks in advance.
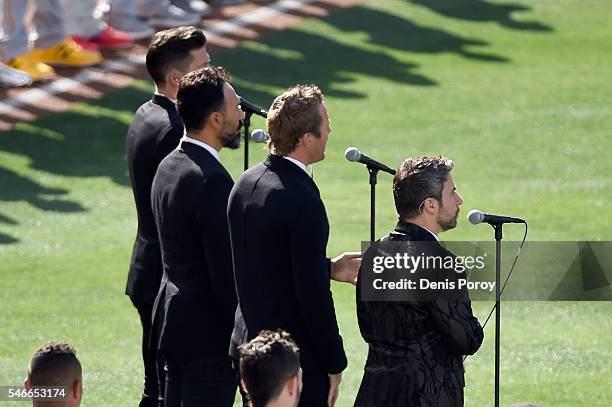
[228,85,360,406]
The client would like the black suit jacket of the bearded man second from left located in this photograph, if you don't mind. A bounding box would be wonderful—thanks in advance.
[151,141,236,362]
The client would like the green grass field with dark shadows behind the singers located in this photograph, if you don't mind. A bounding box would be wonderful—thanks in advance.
[0,0,612,407]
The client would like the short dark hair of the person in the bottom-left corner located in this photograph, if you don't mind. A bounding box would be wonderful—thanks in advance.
[28,341,82,386]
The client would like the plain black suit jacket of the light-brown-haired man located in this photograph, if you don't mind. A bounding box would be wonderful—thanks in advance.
[228,155,347,373]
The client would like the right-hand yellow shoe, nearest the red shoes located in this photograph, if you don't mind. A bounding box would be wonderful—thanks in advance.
[32,38,102,68]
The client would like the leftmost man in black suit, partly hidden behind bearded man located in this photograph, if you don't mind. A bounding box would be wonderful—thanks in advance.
[126,27,210,407]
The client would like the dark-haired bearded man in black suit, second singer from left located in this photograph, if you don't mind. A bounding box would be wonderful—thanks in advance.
[151,67,244,407]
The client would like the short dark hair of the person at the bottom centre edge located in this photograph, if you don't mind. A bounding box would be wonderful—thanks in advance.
[239,330,300,407]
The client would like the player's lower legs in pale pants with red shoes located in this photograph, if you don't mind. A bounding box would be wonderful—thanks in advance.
[64,0,134,50]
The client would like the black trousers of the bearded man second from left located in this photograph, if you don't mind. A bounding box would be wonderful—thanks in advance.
[164,356,237,407]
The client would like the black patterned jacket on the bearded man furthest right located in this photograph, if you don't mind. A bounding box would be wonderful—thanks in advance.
[355,222,483,407]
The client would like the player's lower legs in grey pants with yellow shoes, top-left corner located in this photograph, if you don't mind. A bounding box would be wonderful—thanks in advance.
[0,0,102,81]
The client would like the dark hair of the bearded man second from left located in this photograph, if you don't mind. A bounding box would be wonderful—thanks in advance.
[176,66,229,130]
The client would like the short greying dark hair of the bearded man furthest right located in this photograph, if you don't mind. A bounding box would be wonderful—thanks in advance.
[393,156,454,219]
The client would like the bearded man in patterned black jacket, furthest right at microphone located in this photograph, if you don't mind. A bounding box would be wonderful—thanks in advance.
[355,157,483,407]
